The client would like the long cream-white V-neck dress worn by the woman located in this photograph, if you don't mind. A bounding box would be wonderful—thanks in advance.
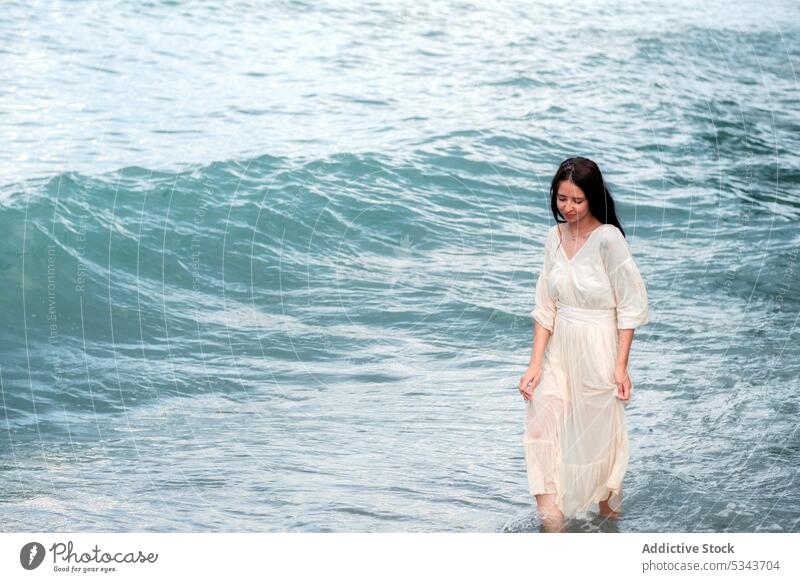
[522,224,648,519]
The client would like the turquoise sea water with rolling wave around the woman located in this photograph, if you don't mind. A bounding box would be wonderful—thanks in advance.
[0,0,800,532]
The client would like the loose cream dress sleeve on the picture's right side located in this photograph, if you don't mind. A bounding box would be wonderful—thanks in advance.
[603,228,649,329]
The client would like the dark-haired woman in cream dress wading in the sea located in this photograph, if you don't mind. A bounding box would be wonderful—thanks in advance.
[519,157,648,531]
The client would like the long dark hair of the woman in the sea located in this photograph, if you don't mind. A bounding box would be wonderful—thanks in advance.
[550,157,625,236]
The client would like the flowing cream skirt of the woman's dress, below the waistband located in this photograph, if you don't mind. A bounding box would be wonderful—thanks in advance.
[522,303,628,519]
